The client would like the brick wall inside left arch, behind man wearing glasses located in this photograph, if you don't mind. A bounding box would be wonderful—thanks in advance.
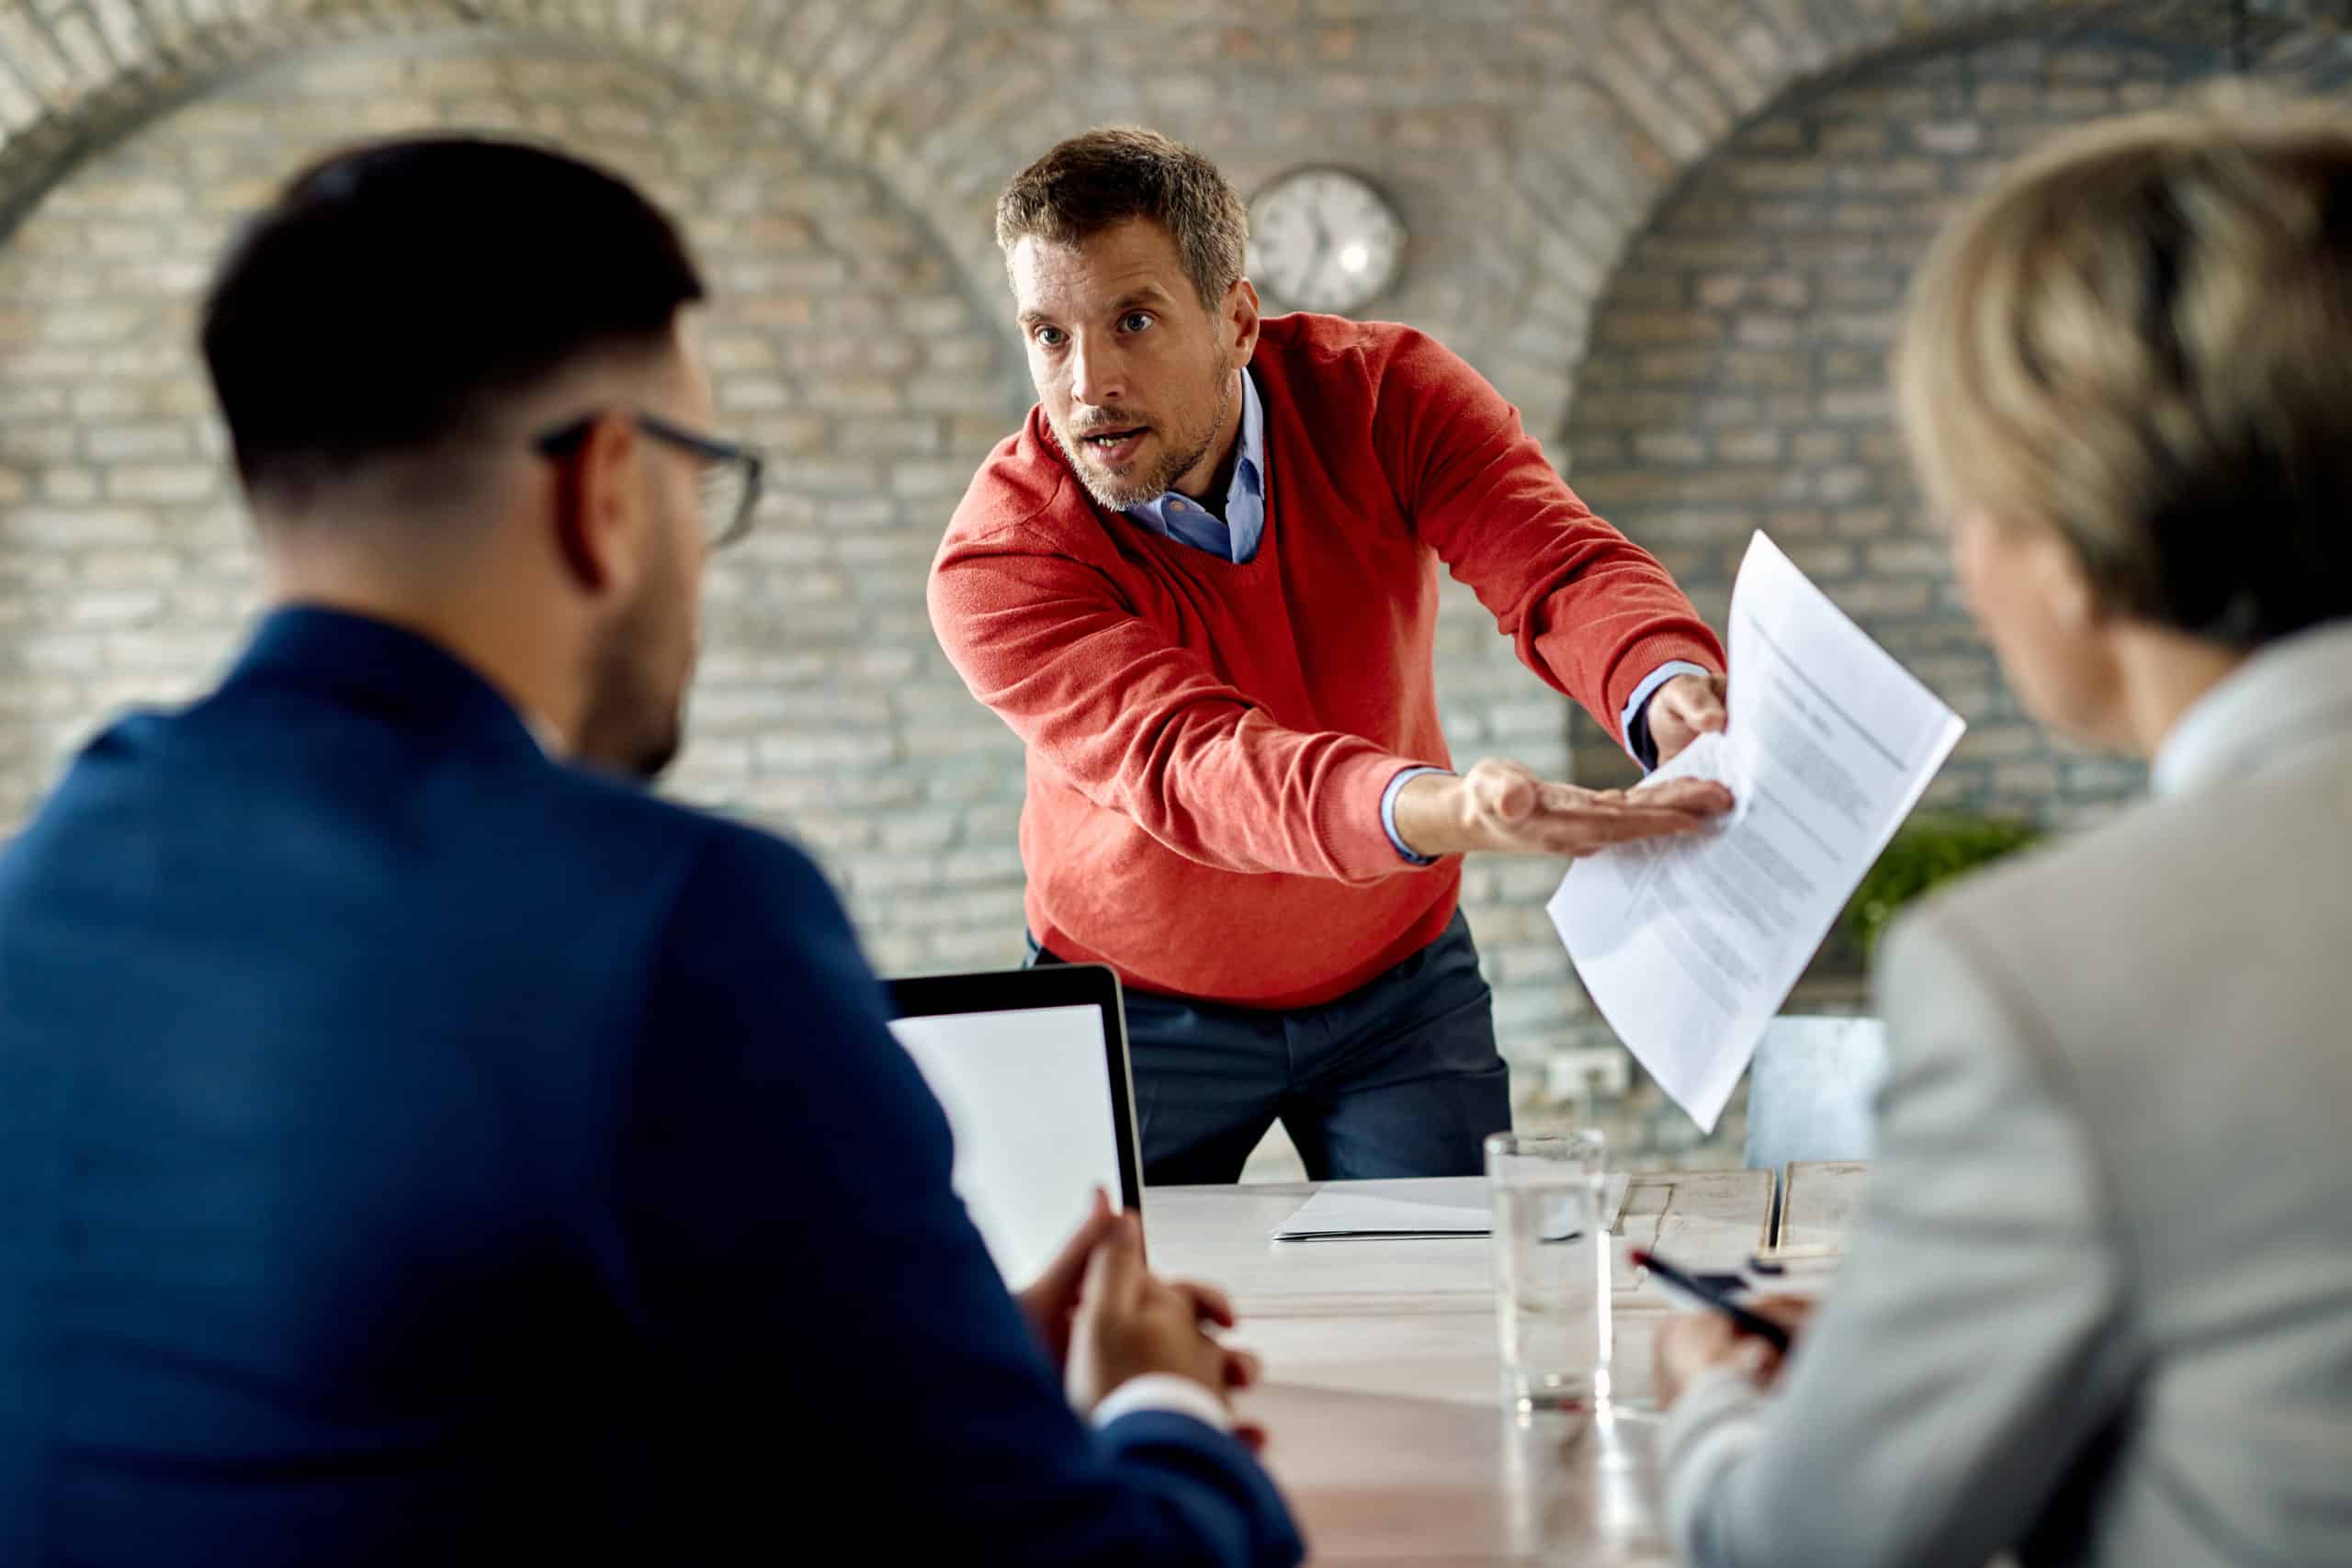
[0,38,1025,968]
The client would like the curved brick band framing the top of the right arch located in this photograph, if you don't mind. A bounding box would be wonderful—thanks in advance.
[1488,0,2343,434]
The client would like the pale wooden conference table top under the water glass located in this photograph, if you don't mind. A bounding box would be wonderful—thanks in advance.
[1143,1166,1863,1568]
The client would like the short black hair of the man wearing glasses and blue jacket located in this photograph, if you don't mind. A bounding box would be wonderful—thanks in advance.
[202,136,703,502]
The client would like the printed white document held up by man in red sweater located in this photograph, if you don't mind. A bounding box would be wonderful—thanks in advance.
[1550,534,1966,1131]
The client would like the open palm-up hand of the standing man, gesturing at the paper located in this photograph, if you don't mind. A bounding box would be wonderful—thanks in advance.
[1397,757,1731,861]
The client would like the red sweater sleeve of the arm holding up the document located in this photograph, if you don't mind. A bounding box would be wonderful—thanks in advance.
[1374,332,1724,743]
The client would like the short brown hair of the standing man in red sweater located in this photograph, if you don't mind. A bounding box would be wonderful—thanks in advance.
[997,125,1249,310]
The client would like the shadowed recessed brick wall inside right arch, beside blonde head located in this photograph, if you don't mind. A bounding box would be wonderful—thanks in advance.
[1559,7,2352,820]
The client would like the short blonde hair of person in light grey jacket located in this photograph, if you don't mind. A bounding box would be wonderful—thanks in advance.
[1894,96,2352,647]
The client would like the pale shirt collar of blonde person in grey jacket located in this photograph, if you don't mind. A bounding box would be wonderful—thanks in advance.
[2150,621,2352,795]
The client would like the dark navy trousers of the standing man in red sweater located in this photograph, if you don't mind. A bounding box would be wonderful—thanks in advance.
[1028,909,1510,1187]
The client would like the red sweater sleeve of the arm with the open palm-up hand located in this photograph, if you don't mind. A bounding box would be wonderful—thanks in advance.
[929,529,1414,882]
